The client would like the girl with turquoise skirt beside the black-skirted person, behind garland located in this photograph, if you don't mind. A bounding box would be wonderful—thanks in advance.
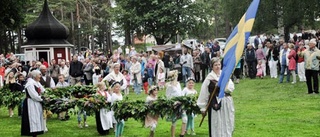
[111,82,124,137]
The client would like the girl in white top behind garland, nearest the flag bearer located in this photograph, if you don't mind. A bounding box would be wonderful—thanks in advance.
[182,77,197,135]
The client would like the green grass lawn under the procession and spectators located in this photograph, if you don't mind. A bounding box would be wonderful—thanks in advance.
[0,78,320,137]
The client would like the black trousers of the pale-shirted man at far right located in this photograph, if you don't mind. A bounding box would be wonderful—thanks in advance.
[306,70,319,94]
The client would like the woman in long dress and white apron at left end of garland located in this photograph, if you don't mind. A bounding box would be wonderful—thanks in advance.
[21,70,45,137]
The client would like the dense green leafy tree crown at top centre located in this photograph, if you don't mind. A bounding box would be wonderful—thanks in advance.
[115,0,202,44]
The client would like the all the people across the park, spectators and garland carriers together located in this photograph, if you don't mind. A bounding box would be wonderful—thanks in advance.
[0,29,320,137]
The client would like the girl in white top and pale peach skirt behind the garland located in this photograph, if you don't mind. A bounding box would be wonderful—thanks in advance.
[144,86,159,137]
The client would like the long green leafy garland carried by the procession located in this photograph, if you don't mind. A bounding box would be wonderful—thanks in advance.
[0,86,200,122]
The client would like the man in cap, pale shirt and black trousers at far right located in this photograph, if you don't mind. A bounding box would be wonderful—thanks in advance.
[298,39,320,94]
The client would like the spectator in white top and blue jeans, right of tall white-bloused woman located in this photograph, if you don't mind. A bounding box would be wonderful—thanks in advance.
[130,56,142,94]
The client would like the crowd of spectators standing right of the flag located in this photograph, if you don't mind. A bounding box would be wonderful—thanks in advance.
[241,32,320,94]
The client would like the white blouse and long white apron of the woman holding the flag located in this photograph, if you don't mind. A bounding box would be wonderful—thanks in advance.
[197,71,235,137]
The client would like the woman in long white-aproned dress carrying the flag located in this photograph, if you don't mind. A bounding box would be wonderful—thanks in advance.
[197,58,235,137]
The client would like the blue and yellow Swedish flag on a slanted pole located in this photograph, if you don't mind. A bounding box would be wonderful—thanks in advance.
[218,0,260,99]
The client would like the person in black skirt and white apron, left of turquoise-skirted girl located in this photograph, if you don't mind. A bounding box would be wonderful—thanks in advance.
[96,82,113,135]
